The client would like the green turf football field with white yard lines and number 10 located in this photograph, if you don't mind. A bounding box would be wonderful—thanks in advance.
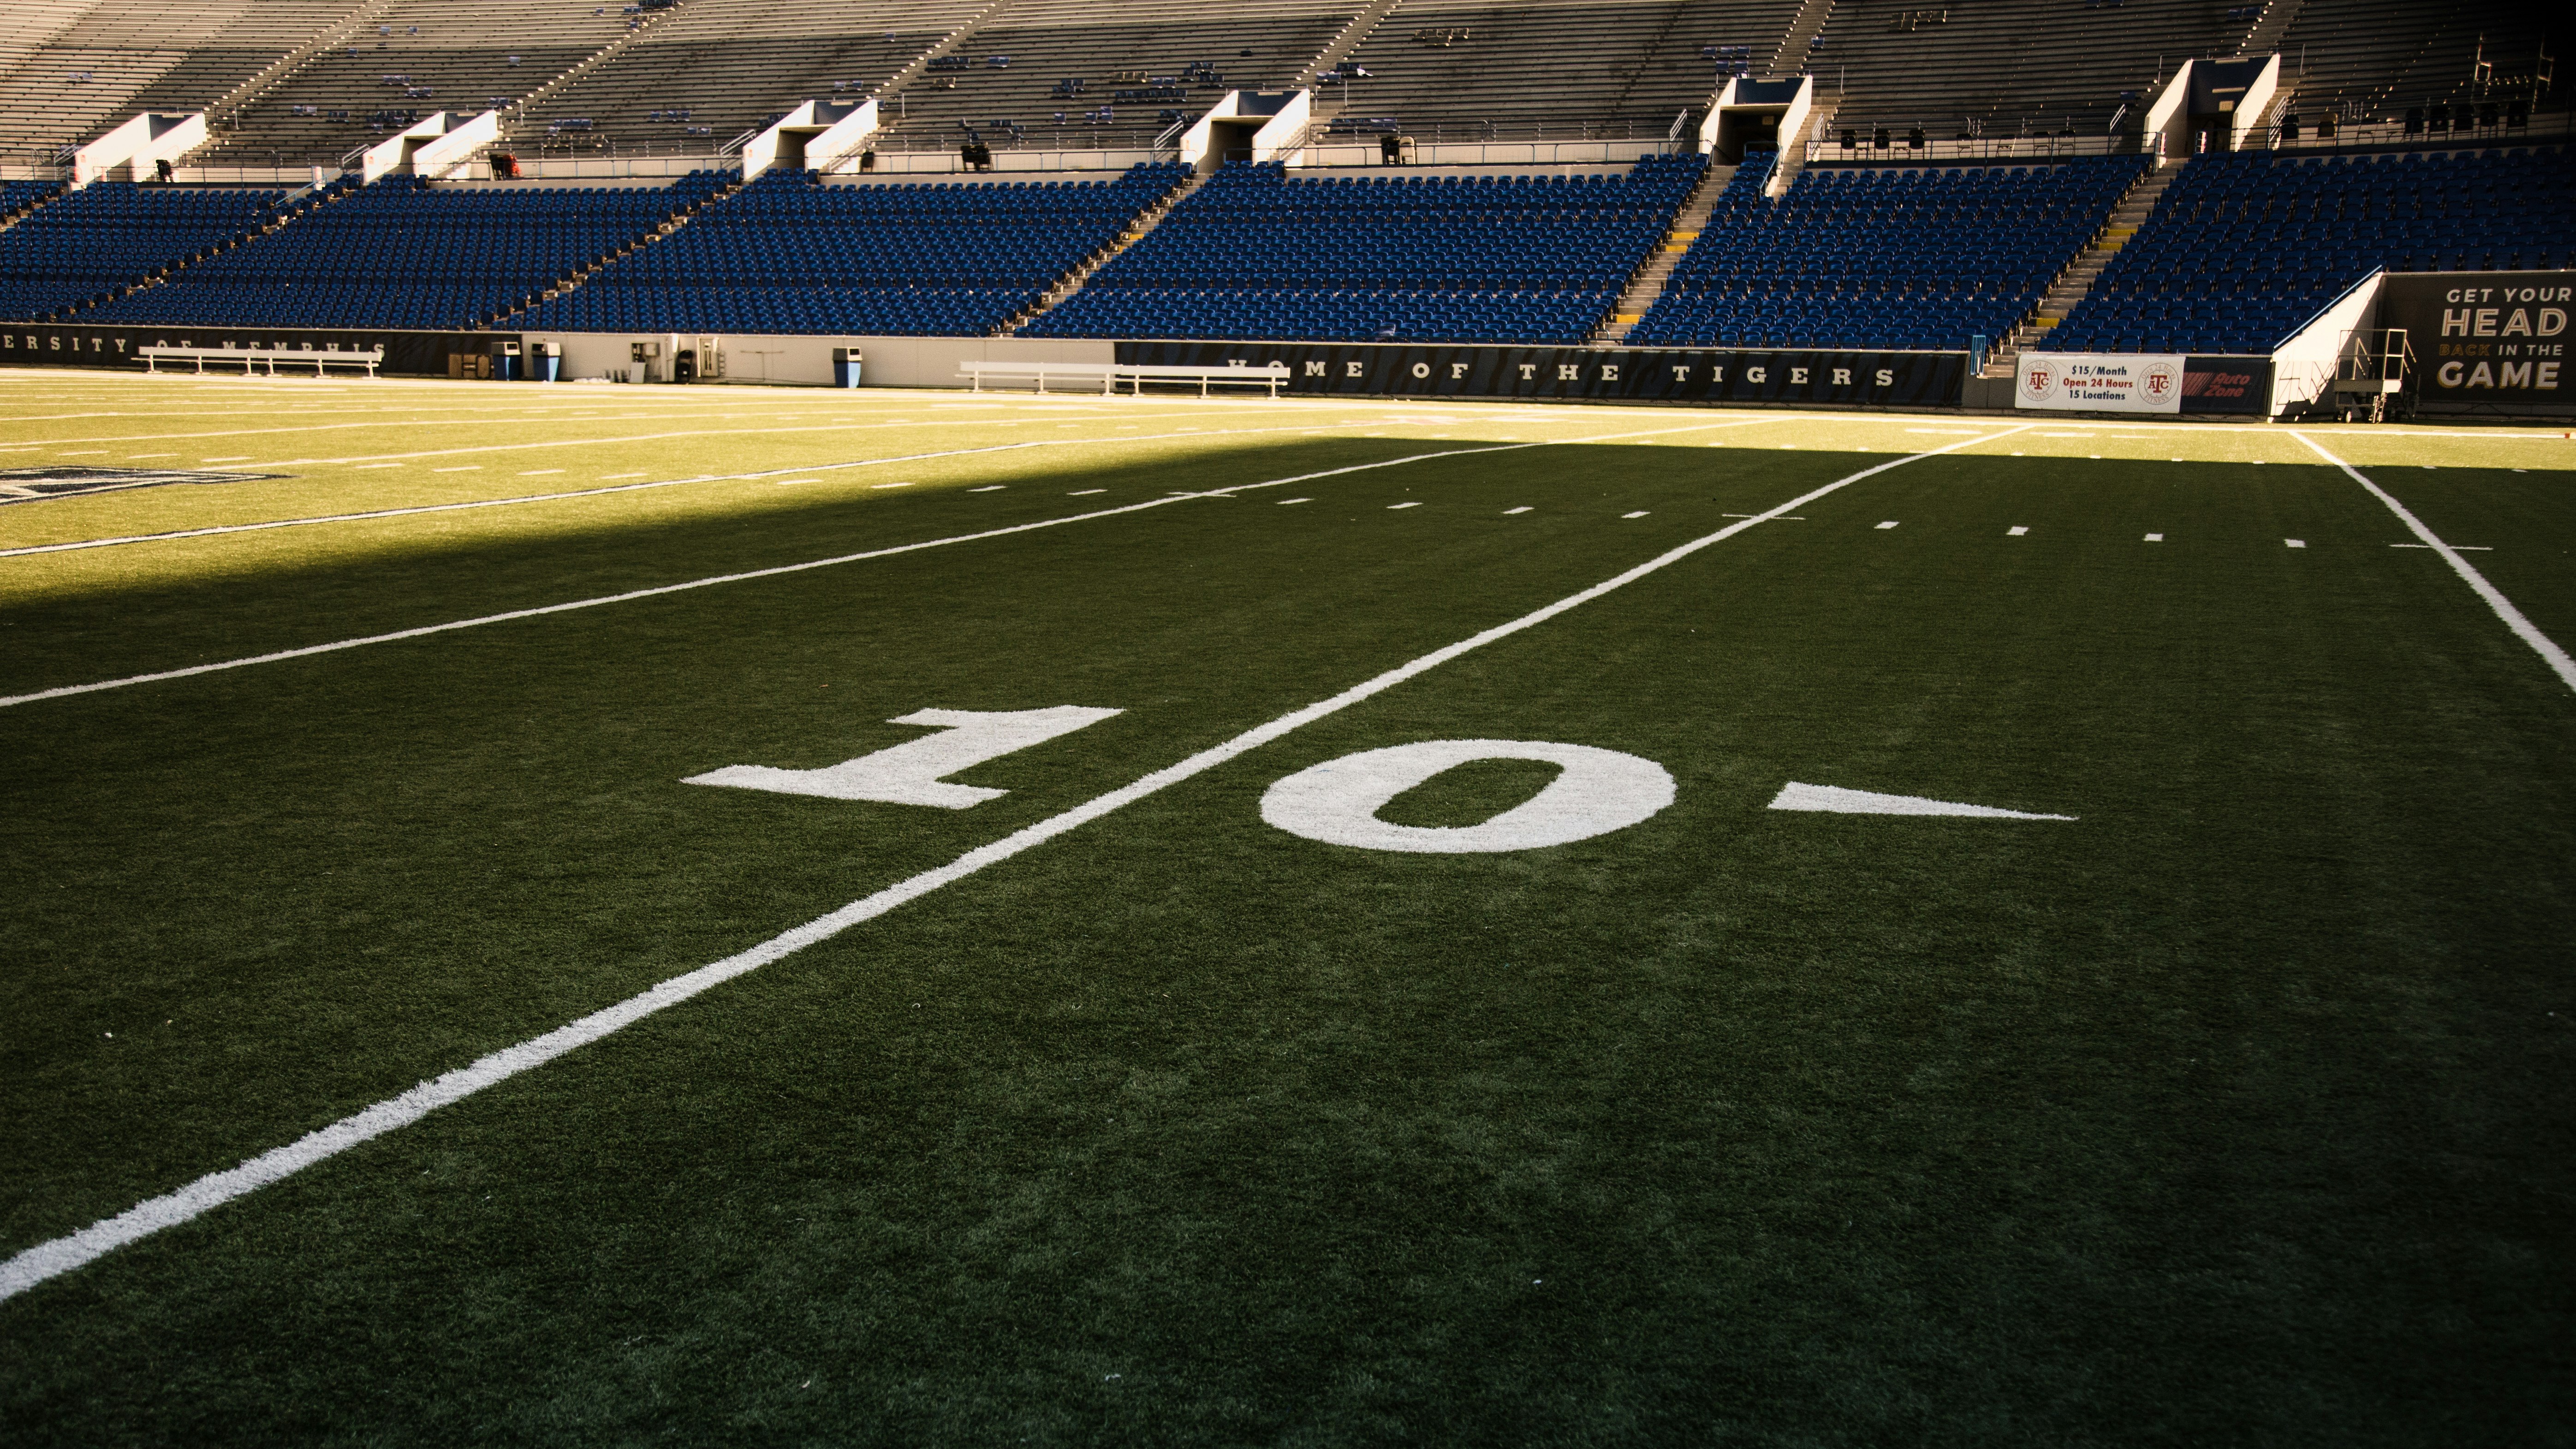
[0,371,2576,1446]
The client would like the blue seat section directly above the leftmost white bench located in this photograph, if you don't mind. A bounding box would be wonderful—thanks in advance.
[98,172,732,327]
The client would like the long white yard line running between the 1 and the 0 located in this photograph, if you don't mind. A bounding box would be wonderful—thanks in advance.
[0,422,2035,1300]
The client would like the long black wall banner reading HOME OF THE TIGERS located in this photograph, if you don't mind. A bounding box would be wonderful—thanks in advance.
[1118,342,1968,407]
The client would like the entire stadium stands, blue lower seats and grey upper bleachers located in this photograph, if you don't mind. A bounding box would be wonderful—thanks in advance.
[0,0,2576,358]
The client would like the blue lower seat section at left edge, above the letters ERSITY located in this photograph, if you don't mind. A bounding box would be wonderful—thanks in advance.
[0,180,286,322]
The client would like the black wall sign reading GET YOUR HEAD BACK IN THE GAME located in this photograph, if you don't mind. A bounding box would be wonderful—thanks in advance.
[2378,270,2576,415]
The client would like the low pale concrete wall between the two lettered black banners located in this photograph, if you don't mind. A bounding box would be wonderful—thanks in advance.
[520,332,1118,389]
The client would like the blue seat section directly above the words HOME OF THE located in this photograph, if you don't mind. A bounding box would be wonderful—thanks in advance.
[1025,154,1708,342]
